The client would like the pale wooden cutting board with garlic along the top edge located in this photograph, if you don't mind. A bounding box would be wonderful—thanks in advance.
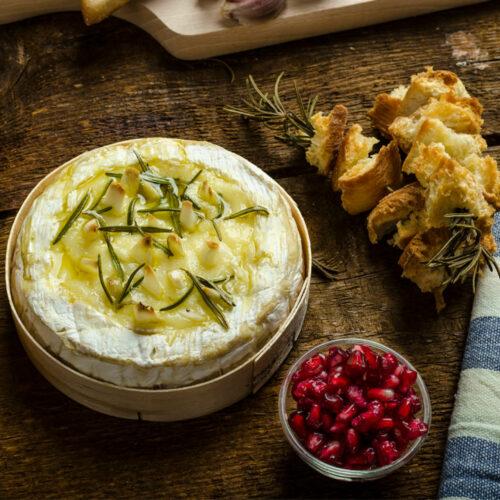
[0,0,484,59]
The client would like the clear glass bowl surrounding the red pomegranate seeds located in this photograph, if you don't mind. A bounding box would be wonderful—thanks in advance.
[278,338,431,481]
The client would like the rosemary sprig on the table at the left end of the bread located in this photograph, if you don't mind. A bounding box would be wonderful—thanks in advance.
[224,73,318,149]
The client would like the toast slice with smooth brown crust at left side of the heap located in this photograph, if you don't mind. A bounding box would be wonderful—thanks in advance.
[339,141,403,215]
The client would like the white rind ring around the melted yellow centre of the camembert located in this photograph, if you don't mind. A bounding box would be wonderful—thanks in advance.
[12,138,304,388]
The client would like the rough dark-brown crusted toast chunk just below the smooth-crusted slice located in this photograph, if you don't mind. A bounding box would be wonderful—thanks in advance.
[367,182,425,243]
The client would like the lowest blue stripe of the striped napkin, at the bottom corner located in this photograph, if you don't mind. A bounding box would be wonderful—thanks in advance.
[439,437,500,500]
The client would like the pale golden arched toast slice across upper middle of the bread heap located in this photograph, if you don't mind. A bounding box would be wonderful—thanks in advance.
[403,118,486,174]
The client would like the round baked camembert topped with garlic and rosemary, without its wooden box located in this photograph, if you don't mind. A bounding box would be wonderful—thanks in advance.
[12,138,304,388]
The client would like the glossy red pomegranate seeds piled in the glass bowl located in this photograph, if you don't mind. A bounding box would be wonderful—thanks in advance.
[289,345,428,470]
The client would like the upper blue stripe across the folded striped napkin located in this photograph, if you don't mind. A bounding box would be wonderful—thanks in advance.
[462,316,500,372]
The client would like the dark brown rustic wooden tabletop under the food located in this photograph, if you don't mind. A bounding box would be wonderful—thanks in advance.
[0,2,500,498]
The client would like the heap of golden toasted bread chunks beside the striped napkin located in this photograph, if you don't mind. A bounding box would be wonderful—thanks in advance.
[313,68,500,311]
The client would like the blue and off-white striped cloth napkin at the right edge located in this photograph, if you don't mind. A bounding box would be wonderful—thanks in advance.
[439,214,500,500]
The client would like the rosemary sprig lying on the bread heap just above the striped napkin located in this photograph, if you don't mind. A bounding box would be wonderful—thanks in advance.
[424,213,500,293]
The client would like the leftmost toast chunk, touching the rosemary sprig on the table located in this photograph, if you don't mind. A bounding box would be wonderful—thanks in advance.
[306,104,347,175]
